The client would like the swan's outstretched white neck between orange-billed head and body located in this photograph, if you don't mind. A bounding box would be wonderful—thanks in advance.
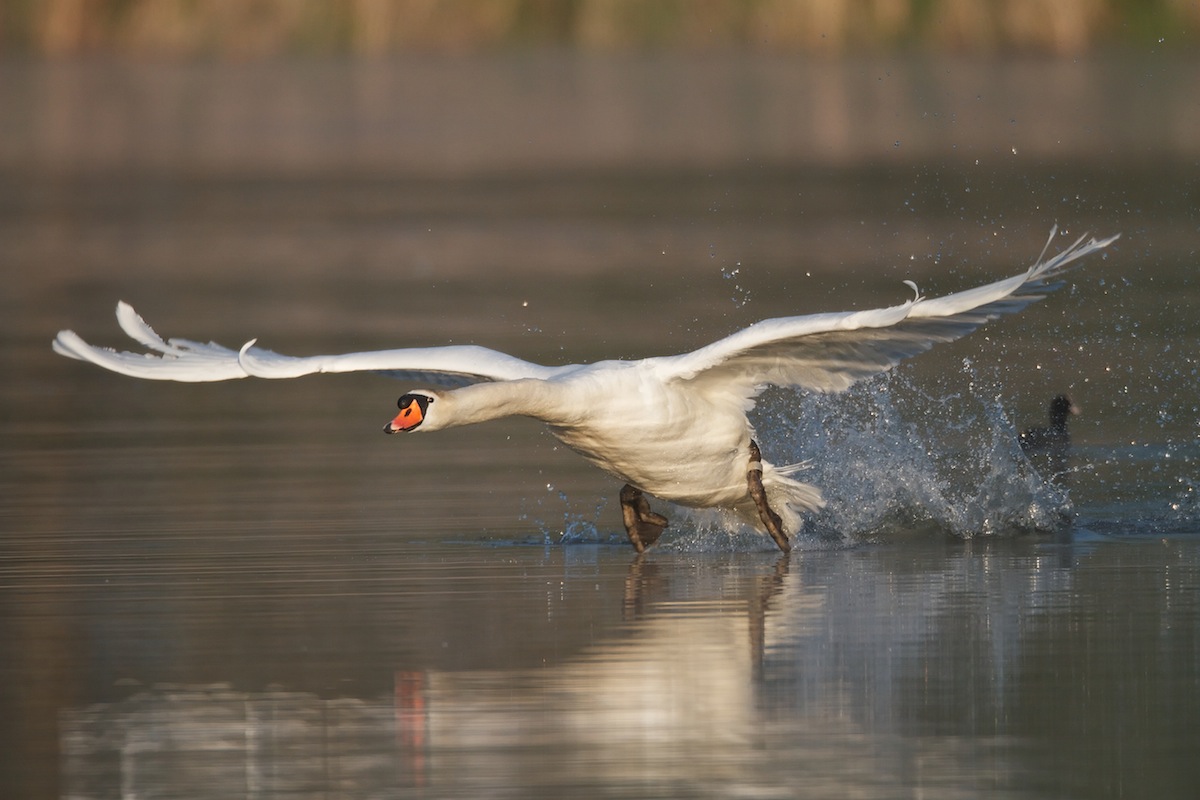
[438,378,572,428]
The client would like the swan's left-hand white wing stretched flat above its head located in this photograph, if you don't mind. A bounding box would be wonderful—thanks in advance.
[54,302,570,386]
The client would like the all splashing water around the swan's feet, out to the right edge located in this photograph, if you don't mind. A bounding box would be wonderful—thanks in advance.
[527,360,1200,552]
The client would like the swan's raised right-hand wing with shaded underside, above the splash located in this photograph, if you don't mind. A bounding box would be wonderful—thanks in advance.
[658,227,1120,397]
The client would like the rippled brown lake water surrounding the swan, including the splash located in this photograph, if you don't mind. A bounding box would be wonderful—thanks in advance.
[0,54,1200,799]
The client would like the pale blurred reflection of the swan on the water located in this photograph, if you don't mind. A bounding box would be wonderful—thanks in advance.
[61,554,806,796]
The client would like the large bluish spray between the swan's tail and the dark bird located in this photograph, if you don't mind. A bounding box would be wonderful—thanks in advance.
[755,374,1072,543]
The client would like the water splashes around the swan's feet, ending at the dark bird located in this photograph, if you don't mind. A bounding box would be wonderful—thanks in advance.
[527,363,1080,552]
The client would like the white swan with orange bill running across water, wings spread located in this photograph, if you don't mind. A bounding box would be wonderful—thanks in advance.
[54,228,1117,552]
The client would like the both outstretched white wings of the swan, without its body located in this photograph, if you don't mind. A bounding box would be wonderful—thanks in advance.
[54,229,1117,396]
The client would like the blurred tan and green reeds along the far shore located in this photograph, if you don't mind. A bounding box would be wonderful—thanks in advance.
[7,0,1200,59]
